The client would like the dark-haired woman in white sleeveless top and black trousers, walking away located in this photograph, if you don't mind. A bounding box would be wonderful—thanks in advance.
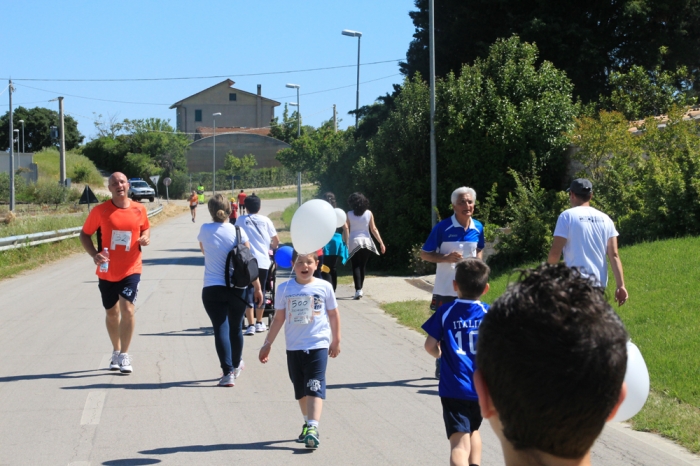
[346,193,386,299]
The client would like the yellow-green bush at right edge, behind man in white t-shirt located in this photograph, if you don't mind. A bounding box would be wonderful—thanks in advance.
[572,108,700,244]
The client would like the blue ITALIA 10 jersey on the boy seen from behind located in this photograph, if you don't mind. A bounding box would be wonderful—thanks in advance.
[423,299,489,401]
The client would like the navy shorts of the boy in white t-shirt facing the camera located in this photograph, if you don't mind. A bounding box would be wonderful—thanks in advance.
[287,348,328,400]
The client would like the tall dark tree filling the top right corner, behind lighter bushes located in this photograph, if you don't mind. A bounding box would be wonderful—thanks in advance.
[401,0,700,102]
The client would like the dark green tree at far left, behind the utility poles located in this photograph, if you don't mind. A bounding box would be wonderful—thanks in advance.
[0,107,85,152]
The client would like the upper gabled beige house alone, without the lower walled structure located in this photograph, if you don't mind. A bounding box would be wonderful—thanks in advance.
[170,79,280,139]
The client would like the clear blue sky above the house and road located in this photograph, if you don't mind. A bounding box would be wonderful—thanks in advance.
[0,0,415,140]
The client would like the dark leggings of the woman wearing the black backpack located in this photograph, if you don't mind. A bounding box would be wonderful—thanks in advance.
[202,286,246,375]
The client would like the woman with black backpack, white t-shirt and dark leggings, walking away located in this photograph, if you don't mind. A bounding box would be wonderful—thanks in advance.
[197,194,263,387]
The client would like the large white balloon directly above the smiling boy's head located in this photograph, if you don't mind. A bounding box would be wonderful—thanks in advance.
[289,199,336,254]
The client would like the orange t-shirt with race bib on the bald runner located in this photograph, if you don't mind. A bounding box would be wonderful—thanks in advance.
[83,200,151,282]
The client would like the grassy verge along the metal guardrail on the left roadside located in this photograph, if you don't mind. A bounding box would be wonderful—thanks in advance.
[0,204,189,280]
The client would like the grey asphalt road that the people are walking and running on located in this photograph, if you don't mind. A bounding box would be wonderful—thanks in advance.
[0,199,698,465]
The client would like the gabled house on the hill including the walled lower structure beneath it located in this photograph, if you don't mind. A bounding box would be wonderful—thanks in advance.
[170,79,289,172]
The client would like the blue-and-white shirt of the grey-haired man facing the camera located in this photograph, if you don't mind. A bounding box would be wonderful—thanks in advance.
[423,215,485,296]
